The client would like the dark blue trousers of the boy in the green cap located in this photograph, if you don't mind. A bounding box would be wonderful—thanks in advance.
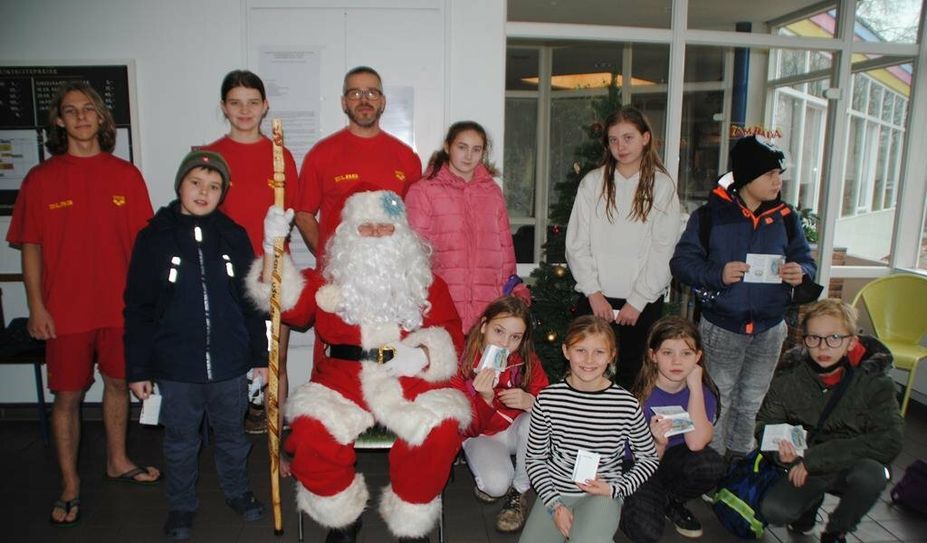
[158,375,251,511]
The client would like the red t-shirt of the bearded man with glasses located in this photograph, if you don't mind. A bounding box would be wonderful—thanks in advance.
[296,128,422,257]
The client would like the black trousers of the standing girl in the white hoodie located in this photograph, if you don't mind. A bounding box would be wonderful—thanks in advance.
[576,296,663,390]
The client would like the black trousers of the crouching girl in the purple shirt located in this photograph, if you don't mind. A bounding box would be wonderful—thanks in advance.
[620,445,724,543]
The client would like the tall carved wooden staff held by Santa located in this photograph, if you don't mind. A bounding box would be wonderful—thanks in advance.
[266,119,286,536]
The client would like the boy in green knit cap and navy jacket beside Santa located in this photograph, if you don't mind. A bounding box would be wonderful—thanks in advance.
[125,151,267,540]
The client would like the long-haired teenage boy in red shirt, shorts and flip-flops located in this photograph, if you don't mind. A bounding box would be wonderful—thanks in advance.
[6,81,161,527]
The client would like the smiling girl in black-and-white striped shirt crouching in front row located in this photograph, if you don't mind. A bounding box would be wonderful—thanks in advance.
[519,315,659,543]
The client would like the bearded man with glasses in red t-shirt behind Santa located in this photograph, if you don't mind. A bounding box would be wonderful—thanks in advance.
[296,66,422,259]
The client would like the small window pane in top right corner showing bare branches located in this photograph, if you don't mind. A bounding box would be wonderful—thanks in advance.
[855,0,921,43]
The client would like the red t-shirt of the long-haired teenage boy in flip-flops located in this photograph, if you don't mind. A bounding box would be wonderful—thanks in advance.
[6,153,152,335]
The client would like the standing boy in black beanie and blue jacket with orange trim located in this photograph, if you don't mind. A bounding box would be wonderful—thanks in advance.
[670,136,817,461]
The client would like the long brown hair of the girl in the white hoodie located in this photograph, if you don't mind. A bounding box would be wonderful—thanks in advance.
[602,106,669,222]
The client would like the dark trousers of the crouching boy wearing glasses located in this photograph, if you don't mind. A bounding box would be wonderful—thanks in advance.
[760,458,888,532]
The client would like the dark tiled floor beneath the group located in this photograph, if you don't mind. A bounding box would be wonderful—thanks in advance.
[0,404,927,543]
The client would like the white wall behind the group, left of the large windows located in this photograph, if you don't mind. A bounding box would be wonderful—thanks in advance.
[0,0,505,403]
